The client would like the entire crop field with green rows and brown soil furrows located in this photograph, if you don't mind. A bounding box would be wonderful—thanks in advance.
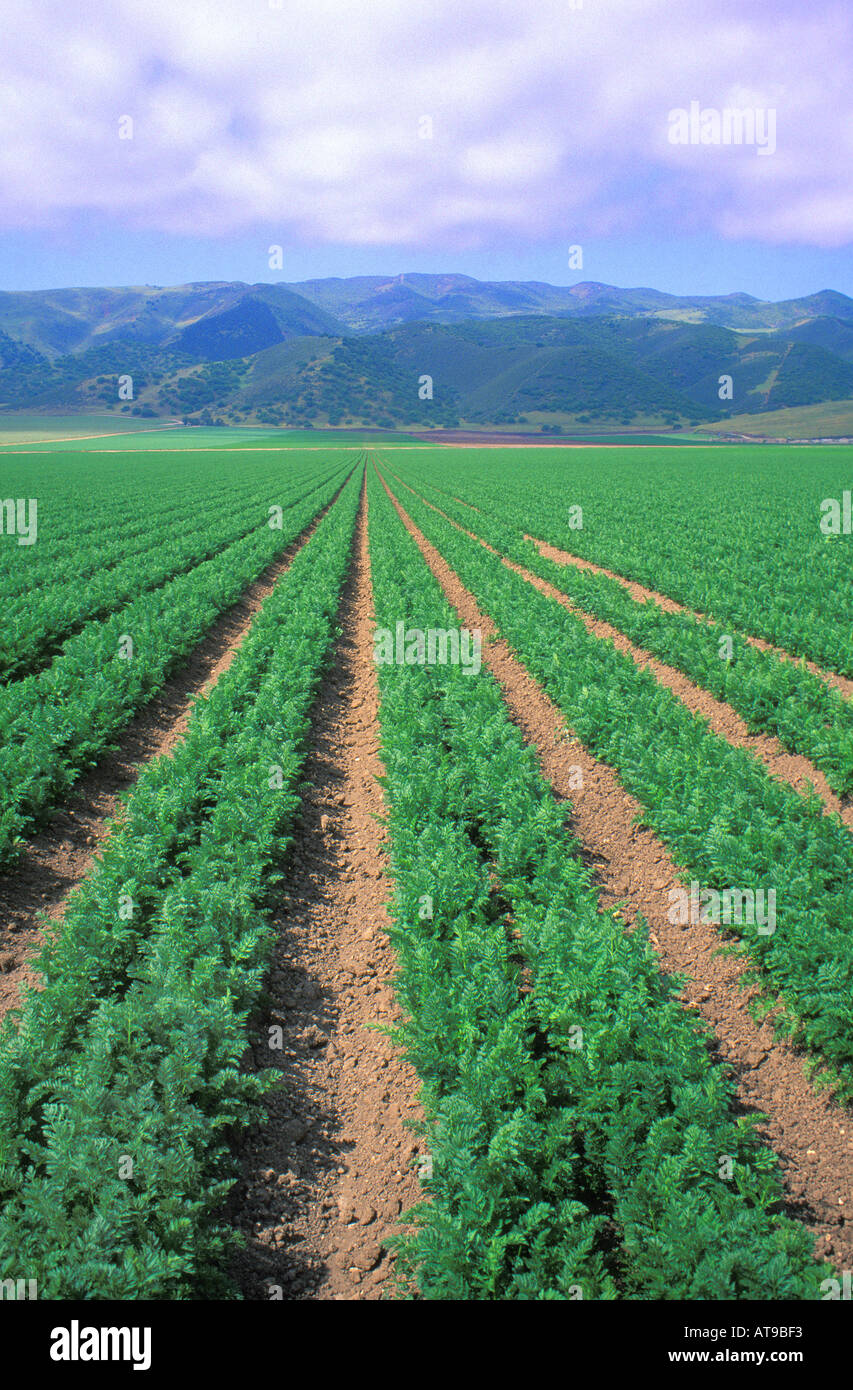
[0,442,853,1302]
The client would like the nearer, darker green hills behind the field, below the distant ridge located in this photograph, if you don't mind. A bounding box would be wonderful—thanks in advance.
[0,311,853,428]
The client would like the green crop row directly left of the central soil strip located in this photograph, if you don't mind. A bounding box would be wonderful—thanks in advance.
[0,474,361,1300]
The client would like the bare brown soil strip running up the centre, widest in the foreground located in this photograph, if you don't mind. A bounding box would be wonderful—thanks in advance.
[229,483,425,1301]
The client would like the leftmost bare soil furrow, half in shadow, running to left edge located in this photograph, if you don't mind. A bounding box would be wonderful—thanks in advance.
[0,489,351,1019]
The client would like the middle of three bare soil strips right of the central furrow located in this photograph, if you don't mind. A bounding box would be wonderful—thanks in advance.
[391,480,853,830]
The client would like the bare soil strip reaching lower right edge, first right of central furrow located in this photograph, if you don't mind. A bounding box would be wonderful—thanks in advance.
[386,472,853,1269]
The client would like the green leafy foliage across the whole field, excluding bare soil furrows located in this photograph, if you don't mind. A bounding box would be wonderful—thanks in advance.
[0,442,853,1301]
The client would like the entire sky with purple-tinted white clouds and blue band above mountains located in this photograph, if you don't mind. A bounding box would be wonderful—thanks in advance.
[0,0,853,299]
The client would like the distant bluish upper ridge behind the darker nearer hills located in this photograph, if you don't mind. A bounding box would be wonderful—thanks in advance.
[0,275,853,360]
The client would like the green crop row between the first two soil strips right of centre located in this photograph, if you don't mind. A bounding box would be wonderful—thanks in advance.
[380,464,853,1099]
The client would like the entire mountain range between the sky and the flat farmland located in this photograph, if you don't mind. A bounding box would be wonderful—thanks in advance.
[0,274,853,428]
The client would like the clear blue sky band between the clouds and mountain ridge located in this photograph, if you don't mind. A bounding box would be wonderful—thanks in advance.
[0,220,853,299]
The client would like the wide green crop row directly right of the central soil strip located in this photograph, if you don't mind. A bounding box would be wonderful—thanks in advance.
[368,475,821,1300]
